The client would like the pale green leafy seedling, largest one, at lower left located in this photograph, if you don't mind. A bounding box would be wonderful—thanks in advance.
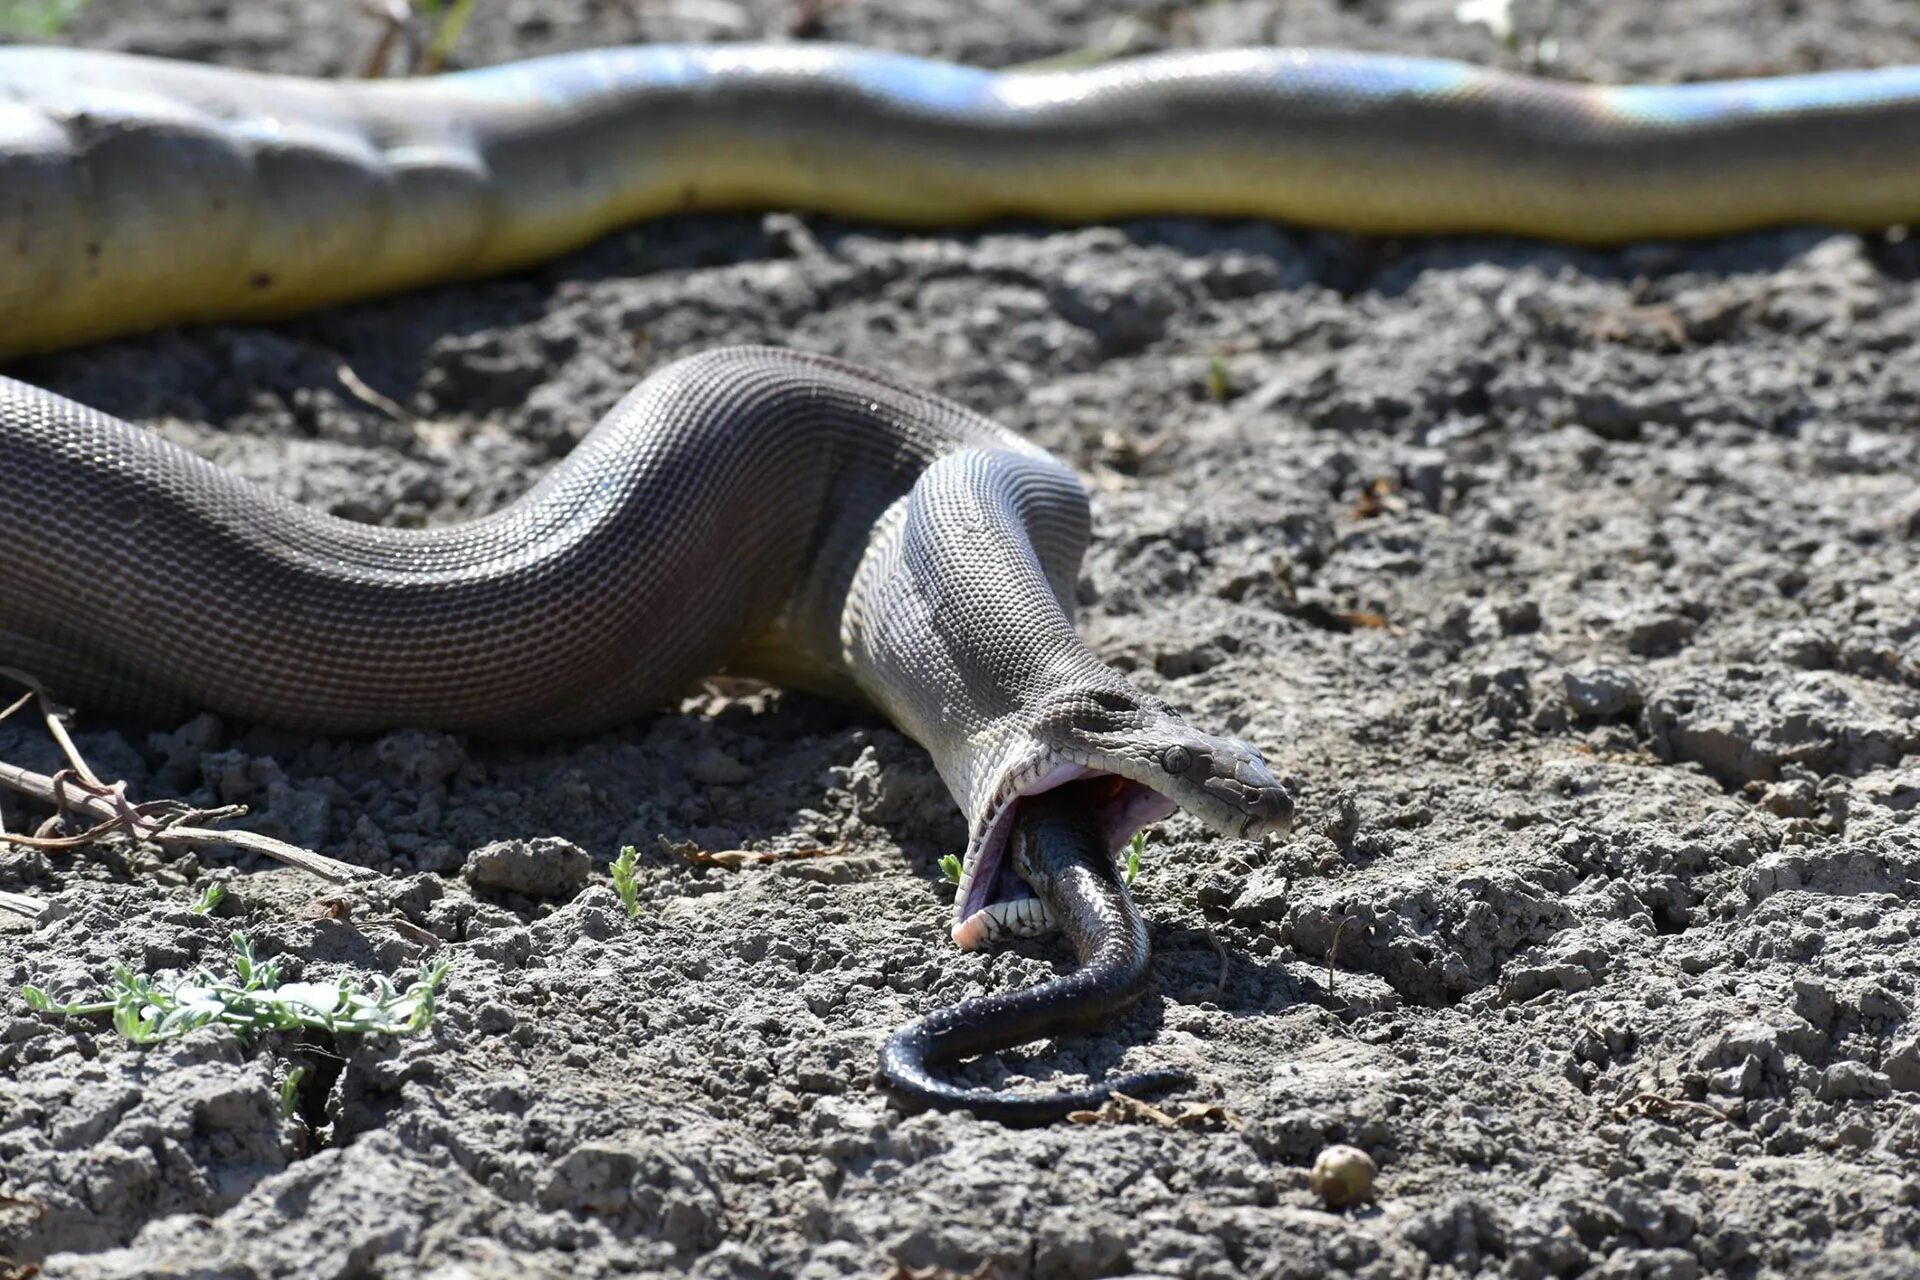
[19,933,447,1044]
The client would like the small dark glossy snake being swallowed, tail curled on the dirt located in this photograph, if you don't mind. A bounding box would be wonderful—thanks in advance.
[879,783,1192,1125]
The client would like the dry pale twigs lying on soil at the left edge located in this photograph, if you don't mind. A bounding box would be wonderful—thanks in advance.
[0,666,372,885]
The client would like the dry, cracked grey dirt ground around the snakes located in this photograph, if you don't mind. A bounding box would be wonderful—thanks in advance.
[0,0,1920,1280]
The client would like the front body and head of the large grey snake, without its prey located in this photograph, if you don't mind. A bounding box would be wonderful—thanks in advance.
[0,347,1292,946]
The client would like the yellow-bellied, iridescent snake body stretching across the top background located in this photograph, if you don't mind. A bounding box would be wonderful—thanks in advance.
[0,44,1920,355]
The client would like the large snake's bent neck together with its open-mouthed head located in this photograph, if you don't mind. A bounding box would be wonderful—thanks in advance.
[841,447,1292,948]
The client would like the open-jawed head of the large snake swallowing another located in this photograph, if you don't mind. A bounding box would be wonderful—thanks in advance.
[952,676,1294,948]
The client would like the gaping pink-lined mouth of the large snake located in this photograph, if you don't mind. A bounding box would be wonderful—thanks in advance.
[952,758,1179,950]
